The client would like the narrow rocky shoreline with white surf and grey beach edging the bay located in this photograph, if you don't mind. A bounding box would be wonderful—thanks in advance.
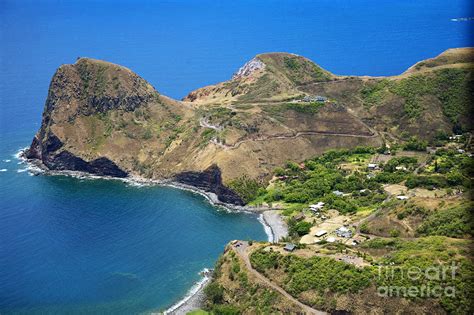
[14,148,288,314]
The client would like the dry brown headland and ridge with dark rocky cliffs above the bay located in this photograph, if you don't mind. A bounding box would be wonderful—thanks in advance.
[25,49,474,204]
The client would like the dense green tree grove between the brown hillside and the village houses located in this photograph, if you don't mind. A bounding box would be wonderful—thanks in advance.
[252,147,386,215]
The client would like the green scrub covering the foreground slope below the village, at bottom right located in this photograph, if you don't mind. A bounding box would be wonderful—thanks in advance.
[250,237,474,314]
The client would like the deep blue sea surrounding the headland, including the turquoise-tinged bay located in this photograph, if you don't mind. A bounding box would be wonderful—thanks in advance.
[0,0,474,314]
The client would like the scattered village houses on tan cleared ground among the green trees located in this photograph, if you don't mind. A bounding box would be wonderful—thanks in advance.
[250,135,472,267]
